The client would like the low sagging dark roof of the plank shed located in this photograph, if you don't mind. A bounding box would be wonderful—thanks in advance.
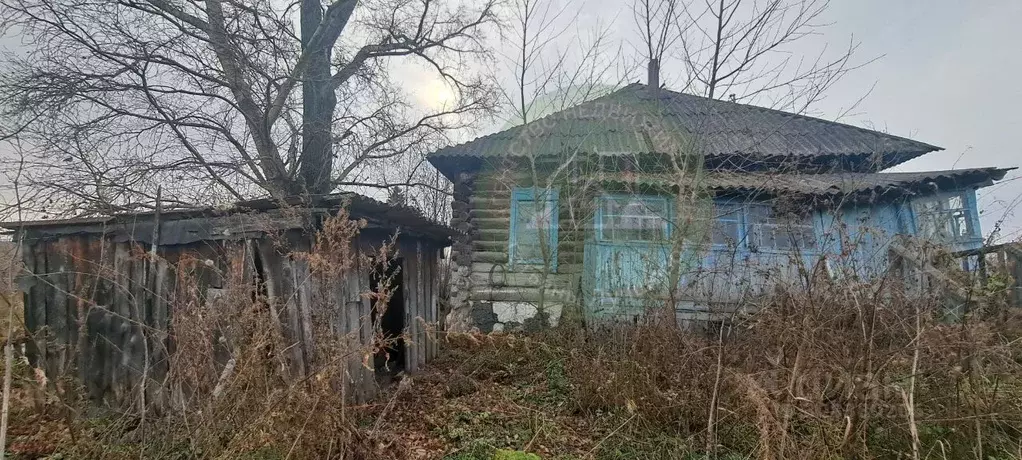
[0,193,456,244]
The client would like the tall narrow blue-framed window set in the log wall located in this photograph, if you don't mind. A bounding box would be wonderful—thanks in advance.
[508,188,557,269]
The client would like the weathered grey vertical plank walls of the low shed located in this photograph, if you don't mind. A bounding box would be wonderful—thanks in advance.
[22,228,439,407]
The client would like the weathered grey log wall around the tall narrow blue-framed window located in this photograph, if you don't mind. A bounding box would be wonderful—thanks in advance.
[449,169,592,332]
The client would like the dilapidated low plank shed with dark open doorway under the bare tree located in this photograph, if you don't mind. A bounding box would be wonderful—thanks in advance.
[0,194,453,406]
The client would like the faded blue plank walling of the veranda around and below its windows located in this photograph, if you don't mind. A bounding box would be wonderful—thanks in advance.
[584,189,982,316]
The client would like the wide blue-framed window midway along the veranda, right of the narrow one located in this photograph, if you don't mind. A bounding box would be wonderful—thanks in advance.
[746,204,817,250]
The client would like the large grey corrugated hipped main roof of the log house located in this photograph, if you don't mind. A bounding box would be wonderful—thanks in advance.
[429,83,941,177]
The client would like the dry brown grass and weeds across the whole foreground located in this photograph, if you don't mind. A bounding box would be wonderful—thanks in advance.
[1,222,1022,460]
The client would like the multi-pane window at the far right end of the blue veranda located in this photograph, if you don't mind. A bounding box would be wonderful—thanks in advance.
[912,193,979,241]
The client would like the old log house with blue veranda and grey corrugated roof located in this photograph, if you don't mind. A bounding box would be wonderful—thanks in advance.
[428,80,1009,330]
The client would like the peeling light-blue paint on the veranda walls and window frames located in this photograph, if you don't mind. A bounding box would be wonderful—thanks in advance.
[583,185,982,317]
